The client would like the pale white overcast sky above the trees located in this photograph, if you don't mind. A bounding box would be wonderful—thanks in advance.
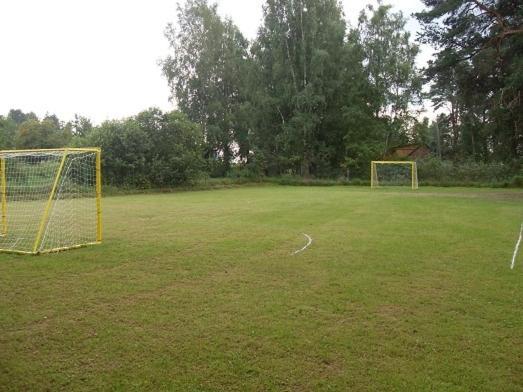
[0,0,431,123]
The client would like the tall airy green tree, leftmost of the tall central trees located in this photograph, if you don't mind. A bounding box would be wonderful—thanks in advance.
[163,0,253,175]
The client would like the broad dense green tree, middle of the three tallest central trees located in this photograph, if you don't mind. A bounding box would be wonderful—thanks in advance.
[252,0,345,176]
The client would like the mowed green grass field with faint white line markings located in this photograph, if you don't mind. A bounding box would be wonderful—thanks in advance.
[0,186,523,391]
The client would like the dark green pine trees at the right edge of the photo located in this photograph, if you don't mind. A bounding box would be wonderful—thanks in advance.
[417,0,523,161]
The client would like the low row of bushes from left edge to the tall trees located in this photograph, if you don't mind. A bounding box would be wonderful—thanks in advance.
[0,109,209,188]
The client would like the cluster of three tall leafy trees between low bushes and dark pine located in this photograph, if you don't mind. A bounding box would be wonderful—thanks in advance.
[163,0,430,177]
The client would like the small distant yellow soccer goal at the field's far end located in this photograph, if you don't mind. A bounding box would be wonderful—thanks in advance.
[370,161,418,189]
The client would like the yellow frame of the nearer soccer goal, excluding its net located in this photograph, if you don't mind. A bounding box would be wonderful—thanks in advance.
[0,147,102,255]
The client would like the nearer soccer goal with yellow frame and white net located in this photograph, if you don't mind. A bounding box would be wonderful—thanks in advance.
[0,148,102,254]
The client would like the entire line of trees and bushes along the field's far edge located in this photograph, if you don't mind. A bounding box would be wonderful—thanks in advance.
[0,0,523,186]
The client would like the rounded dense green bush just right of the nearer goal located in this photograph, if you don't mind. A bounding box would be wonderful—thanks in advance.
[81,109,205,187]
